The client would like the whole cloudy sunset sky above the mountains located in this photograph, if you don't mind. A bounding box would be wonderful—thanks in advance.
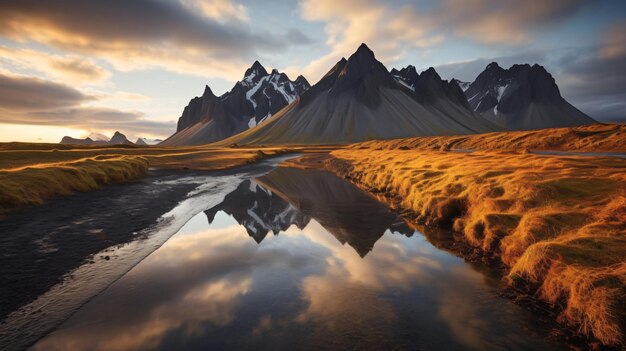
[0,0,626,142]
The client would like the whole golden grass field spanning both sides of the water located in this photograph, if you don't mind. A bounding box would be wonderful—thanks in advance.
[0,125,626,345]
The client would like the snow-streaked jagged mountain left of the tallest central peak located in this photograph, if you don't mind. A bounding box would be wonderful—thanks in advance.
[162,61,310,146]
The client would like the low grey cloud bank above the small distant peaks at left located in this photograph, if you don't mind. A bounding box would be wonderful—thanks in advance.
[0,74,176,136]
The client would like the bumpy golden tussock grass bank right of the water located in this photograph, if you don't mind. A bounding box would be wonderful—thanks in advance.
[318,148,626,345]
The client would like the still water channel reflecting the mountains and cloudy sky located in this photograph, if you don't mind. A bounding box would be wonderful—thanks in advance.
[34,168,558,350]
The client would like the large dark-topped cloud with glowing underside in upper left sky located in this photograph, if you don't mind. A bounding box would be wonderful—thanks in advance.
[0,0,308,79]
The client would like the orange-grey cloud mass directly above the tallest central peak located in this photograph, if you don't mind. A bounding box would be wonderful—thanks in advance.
[288,0,585,80]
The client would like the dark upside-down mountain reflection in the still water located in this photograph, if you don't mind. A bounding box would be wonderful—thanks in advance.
[205,168,413,257]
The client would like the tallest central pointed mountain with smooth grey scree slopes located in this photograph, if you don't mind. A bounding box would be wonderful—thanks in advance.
[210,44,497,144]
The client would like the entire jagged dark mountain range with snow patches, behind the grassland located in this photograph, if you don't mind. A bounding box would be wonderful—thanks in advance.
[163,44,595,145]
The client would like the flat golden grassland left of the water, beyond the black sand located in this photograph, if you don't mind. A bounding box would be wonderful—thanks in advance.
[0,143,289,214]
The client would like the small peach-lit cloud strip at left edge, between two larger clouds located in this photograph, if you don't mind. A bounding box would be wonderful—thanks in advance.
[0,45,111,84]
